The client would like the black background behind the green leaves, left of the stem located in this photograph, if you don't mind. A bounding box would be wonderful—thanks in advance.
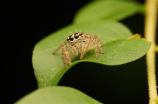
[0,0,158,104]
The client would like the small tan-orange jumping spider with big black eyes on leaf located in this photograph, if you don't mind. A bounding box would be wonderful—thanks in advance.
[53,32,104,68]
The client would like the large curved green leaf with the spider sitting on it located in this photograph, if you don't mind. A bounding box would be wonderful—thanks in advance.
[32,21,150,88]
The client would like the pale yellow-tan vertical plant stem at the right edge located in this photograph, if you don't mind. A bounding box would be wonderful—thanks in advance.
[145,0,157,104]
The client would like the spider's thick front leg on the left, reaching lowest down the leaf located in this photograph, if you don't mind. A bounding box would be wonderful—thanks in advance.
[62,45,71,67]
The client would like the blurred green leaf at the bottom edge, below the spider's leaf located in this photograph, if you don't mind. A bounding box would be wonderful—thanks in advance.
[15,86,102,104]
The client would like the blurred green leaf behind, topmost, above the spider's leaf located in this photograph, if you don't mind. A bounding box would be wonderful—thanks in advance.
[74,0,143,23]
